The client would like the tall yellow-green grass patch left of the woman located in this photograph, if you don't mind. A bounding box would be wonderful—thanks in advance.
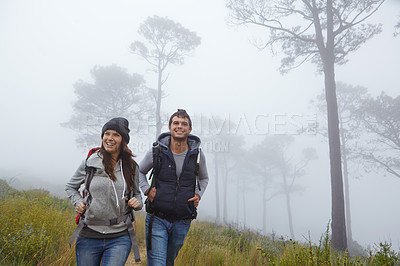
[0,180,75,265]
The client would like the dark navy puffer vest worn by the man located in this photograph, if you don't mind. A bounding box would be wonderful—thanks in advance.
[151,133,200,220]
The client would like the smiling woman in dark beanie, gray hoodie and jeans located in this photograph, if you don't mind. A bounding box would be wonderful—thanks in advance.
[65,117,142,266]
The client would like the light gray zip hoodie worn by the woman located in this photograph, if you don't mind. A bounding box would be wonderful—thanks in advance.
[65,152,143,234]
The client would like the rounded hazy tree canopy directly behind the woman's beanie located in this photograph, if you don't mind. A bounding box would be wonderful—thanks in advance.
[62,65,151,149]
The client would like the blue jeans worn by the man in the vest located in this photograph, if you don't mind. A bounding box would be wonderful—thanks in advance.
[146,214,192,266]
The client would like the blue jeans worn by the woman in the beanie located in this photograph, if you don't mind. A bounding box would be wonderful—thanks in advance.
[75,236,132,266]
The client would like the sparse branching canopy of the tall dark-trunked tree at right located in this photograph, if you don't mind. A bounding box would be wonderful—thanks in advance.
[227,0,384,73]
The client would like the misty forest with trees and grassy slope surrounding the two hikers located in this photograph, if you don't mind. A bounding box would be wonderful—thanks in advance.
[0,0,400,265]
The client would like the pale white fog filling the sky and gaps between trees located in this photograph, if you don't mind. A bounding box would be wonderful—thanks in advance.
[0,0,400,252]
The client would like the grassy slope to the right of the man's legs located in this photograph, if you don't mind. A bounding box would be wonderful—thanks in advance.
[176,222,400,266]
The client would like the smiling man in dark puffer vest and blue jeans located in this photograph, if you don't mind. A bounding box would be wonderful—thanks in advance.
[139,109,208,265]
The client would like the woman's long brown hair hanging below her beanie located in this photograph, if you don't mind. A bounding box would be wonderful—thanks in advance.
[100,139,138,189]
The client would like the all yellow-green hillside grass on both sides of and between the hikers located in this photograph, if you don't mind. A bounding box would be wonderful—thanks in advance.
[0,180,400,265]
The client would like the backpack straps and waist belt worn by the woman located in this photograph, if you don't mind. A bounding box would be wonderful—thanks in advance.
[69,147,140,262]
